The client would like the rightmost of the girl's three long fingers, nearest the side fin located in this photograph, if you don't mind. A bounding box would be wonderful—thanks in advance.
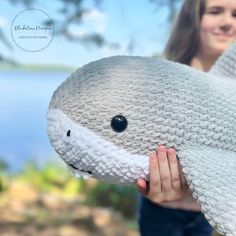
[167,148,181,191]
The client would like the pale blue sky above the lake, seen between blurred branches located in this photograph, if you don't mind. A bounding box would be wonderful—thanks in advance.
[0,0,175,67]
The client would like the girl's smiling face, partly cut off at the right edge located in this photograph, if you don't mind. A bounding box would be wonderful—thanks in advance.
[200,0,236,56]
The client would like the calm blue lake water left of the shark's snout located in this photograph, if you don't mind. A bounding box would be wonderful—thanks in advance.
[0,71,70,170]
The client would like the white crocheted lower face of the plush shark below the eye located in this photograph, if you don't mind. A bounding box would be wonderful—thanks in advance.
[48,109,148,184]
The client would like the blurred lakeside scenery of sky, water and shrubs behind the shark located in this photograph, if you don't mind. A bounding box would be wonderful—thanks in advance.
[0,0,221,236]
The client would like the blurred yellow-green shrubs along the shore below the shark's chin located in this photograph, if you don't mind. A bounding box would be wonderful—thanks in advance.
[0,162,136,219]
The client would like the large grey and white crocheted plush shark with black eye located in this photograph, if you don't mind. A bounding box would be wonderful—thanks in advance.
[48,44,236,236]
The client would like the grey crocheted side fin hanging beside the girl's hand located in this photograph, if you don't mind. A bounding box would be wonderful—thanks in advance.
[178,146,236,236]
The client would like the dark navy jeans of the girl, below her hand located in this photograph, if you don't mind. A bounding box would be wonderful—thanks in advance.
[138,197,213,236]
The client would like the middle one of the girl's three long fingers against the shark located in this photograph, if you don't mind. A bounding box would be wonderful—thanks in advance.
[157,145,172,192]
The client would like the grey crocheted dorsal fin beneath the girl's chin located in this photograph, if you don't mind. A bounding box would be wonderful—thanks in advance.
[209,42,236,79]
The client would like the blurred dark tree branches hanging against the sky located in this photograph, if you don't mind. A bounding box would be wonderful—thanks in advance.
[0,0,115,58]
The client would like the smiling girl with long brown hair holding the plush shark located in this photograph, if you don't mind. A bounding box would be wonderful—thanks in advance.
[137,0,236,236]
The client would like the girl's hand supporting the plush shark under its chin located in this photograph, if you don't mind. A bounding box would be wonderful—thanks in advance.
[136,145,187,203]
